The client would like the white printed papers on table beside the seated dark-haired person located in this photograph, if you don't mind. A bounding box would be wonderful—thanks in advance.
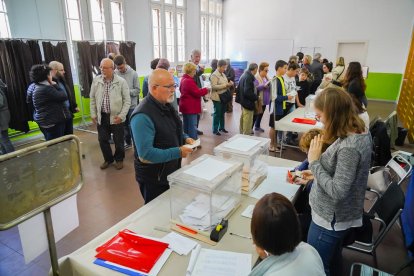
[186,245,252,276]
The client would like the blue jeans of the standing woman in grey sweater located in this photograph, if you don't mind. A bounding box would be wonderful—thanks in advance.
[308,221,348,276]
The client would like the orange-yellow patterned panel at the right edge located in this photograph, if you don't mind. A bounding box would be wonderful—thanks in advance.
[397,28,414,143]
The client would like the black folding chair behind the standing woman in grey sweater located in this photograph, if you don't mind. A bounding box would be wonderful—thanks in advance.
[346,182,405,267]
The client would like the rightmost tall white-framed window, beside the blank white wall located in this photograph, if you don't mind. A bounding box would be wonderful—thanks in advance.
[200,0,223,62]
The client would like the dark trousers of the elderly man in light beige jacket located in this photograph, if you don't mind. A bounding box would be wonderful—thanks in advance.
[98,113,125,163]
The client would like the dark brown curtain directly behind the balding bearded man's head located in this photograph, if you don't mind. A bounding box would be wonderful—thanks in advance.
[42,41,74,93]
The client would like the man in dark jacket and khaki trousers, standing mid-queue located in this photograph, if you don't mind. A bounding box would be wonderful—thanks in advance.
[239,63,258,135]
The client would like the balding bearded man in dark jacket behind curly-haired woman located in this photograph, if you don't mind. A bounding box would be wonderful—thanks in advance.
[49,61,79,135]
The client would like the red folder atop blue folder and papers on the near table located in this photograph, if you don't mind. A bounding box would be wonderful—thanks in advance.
[94,229,172,276]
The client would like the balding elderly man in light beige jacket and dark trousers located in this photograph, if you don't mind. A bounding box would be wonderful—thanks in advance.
[90,58,131,170]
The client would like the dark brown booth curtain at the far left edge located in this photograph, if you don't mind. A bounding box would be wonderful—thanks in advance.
[0,40,34,132]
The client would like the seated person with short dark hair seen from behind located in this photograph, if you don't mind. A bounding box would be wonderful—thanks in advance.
[249,193,325,276]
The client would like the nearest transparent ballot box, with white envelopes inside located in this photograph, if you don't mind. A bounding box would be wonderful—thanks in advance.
[167,154,243,231]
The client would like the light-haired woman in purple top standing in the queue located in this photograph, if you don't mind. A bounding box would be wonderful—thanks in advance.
[253,62,270,132]
